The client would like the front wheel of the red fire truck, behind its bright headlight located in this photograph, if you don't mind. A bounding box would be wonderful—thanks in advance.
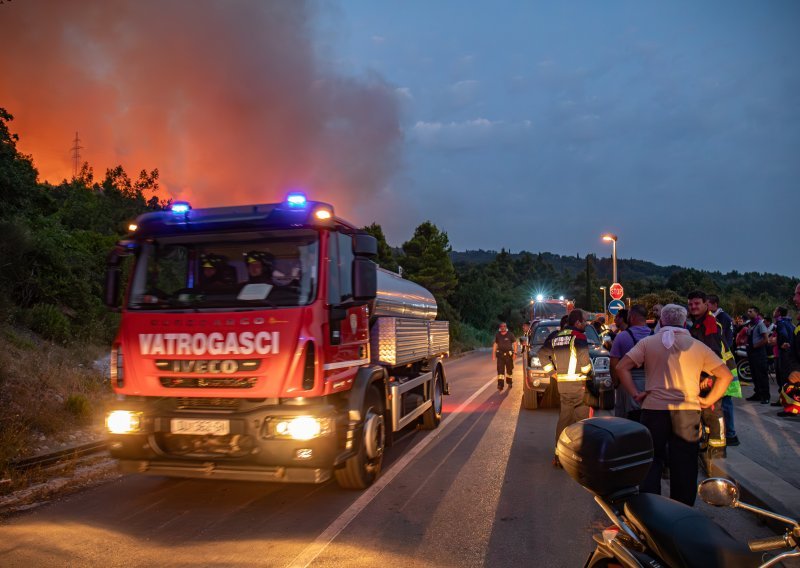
[334,387,386,489]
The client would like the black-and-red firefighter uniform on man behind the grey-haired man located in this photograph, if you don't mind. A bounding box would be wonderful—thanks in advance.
[687,312,742,451]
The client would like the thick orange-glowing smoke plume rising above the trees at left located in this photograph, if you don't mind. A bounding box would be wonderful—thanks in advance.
[0,0,400,214]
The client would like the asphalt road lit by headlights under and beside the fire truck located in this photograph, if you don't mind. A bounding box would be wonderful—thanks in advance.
[0,351,784,568]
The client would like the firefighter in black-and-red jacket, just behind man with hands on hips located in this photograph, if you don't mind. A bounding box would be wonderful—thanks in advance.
[686,290,742,466]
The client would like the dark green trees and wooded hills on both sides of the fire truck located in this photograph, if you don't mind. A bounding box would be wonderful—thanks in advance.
[0,108,795,349]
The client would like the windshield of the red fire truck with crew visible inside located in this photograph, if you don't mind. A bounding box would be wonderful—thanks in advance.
[128,230,319,310]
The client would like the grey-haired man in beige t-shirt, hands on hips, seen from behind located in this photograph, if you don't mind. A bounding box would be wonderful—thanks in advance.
[616,304,733,506]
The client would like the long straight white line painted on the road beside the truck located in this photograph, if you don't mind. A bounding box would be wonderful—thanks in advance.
[289,376,497,568]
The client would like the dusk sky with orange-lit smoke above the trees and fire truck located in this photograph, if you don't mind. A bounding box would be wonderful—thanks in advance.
[0,0,800,276]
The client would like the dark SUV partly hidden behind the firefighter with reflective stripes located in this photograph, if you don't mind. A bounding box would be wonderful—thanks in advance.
[522,320,613,409]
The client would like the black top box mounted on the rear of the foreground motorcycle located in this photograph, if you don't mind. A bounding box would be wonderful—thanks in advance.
[558,417,653,497]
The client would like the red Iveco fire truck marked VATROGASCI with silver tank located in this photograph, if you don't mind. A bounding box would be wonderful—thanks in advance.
[105,194,449,488]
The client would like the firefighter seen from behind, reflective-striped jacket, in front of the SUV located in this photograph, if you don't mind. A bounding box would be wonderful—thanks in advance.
[538,309,592,467]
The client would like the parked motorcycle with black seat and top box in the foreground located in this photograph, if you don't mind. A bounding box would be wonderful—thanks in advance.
[558,417,800,568]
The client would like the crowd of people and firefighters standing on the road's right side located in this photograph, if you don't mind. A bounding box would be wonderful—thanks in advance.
[512,284,800,505]
